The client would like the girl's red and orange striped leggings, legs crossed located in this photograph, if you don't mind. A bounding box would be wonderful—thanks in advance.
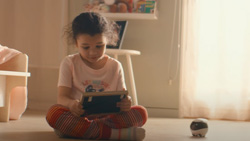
[46,105,148,139]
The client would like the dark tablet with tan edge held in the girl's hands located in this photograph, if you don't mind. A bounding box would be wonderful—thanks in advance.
[81,91,128,116]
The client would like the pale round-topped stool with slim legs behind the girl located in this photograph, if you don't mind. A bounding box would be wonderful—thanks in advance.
[106,49,141,105]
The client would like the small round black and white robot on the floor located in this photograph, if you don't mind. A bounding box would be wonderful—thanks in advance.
[190,118,208,137]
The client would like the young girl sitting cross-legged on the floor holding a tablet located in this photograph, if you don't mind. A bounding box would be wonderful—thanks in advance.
[46,12,147,140]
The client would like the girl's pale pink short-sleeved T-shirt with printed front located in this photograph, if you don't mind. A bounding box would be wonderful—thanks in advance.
[58,53,126,99]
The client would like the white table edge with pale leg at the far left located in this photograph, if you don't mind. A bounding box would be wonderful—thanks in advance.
[0,71,30,107]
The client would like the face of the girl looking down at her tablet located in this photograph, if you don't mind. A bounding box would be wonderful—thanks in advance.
[76,34,107,65]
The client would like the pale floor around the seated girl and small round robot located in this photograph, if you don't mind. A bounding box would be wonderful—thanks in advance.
[0,111,250,141]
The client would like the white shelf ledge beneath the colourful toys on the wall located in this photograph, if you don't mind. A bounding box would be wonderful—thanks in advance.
[100,12,158,20]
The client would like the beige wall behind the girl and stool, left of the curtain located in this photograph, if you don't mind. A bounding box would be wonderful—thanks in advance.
[69,0,182,117]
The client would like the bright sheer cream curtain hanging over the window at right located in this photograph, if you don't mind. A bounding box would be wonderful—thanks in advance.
[180,0,250,120]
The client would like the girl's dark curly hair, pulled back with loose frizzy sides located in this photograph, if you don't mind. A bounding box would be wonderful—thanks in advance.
[66,12,119,45]
